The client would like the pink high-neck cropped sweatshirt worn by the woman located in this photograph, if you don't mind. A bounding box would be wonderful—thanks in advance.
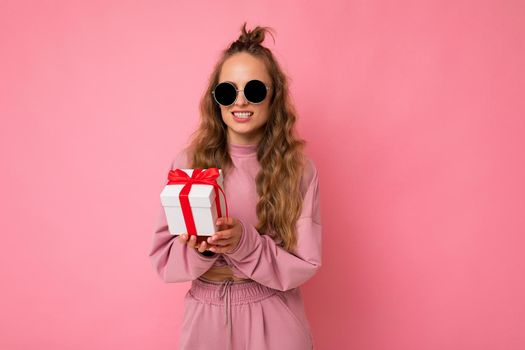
[145,144,322,291]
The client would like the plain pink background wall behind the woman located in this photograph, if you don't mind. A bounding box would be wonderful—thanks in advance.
[0,0,525,350]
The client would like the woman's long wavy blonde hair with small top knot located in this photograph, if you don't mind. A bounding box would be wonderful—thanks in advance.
[187,23,306,251]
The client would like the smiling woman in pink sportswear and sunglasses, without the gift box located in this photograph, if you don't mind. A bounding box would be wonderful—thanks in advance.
[146,23,321,350]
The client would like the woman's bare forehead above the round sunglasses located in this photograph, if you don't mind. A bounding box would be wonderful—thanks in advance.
[219,52,270,85]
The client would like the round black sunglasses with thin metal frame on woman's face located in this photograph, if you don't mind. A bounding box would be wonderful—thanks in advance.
[211,79,270,107]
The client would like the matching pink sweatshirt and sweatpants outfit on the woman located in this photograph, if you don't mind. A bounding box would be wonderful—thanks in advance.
[149,144,322,350]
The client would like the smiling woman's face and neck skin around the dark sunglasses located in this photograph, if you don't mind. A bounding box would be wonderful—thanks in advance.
[219,52,273,145]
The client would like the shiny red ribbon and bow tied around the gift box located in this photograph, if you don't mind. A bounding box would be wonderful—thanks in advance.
[168,168,228,236]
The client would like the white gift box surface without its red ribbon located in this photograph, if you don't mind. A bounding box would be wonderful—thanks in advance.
[160,169,226,236]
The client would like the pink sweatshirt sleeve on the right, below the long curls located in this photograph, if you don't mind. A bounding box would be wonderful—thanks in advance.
[224,160,322,291]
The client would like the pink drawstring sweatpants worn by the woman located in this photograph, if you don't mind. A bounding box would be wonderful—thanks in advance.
[179,278,313,350]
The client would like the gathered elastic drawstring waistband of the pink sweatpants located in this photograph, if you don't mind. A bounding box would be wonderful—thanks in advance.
[189,278,278,305]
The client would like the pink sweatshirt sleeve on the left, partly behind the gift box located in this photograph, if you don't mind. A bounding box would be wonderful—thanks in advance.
[149,152,219,283]
